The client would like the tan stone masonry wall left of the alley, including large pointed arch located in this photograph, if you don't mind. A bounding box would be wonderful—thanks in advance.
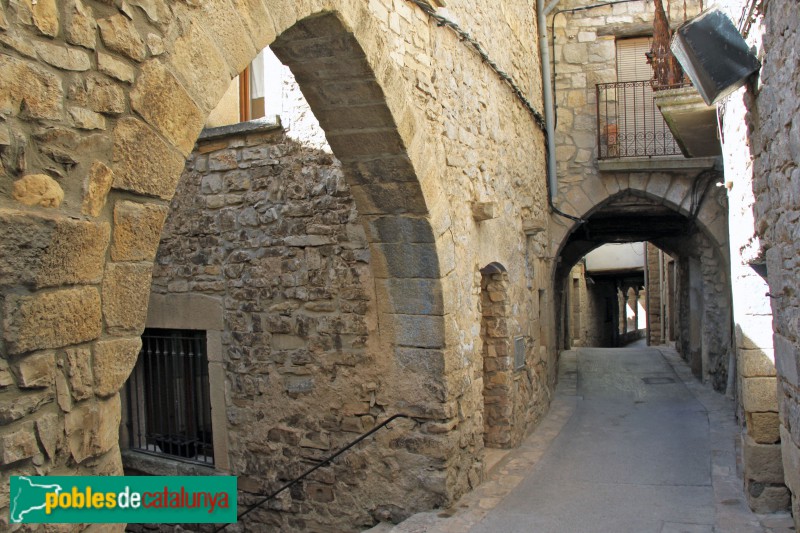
[0,0,557,529]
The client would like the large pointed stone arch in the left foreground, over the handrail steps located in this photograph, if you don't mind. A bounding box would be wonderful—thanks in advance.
[0,0,456,505]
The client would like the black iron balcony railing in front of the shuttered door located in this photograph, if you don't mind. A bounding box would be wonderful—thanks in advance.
[597,80,681,159]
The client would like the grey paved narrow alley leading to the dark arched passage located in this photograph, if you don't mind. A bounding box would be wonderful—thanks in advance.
[374,346,793,533]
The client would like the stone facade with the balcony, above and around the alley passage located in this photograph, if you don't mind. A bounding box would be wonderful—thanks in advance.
[549,1,730,391]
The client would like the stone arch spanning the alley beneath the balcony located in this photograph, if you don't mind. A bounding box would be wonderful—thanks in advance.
[551,175,730,389]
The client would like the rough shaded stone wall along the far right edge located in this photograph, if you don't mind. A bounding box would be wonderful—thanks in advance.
[745,0,800,528]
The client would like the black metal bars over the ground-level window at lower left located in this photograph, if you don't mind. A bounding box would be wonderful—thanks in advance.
[127,329,214,465]
